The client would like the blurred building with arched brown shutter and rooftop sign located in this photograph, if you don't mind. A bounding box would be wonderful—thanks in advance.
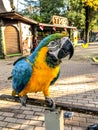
[0,0,76,58]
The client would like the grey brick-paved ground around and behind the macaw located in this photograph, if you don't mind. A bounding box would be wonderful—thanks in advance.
[0,44,98,130]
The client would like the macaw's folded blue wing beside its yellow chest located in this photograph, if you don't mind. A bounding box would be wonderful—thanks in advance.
[12,59,32,94]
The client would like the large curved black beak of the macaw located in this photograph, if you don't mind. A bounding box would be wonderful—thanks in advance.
[58,39,74,59]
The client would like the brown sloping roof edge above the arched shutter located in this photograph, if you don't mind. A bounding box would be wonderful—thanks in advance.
[0,11,38,24]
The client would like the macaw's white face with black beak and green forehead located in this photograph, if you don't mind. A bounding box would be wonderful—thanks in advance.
[47,34,74,60]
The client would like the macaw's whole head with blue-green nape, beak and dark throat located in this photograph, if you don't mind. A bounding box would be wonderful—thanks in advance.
[30,33,74,67]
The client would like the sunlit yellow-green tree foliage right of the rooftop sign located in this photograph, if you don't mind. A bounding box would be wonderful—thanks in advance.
[65,0,85,29]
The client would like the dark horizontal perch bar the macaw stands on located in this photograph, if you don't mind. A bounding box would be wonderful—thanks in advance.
[0,94,98,116]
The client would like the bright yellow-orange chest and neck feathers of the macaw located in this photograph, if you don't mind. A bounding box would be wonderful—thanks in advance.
[20,47,60,95]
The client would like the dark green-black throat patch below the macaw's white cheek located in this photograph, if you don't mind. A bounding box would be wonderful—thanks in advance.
[46,53,61,68]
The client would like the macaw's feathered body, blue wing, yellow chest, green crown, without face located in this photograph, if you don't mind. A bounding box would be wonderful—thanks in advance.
[12,34,70,97]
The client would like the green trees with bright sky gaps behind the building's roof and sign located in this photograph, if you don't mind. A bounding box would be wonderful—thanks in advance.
[18,0,66,23]
